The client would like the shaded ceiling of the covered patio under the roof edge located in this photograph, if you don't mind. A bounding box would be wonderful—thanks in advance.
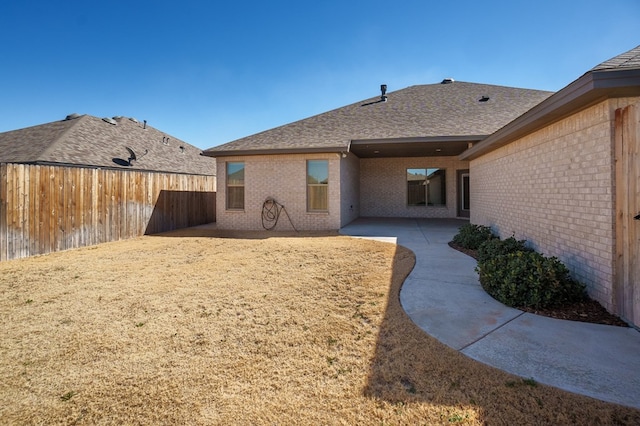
[349,136,485,158]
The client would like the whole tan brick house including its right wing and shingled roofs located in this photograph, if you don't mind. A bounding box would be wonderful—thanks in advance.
[204,46,640,325]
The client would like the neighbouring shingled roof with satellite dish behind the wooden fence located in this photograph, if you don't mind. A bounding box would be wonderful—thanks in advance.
[0,114,216,175]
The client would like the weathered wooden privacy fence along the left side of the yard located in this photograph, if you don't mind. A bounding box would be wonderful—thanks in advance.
[0,163,216,261]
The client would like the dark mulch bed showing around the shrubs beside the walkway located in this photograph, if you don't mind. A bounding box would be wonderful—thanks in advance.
[449,242,629,327]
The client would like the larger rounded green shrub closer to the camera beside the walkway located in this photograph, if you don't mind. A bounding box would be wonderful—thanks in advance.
[477,251,585,309]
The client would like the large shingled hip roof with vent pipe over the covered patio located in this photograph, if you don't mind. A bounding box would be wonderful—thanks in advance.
[204,79,551,157]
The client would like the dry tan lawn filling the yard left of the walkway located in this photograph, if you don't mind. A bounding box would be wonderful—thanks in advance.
[0,229,640,425]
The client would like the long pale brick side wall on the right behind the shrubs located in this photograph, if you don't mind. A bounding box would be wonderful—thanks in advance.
[470,101,636,310]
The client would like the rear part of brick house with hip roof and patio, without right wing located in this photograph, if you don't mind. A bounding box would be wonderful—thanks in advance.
[204,79,551,230]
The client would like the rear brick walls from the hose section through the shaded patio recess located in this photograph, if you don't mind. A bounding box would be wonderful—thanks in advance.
[216,153,469,230]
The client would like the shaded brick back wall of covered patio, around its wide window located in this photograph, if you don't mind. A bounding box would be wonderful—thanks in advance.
[360,157,469,218]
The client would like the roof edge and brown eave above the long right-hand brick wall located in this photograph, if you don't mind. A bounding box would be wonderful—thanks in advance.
[460,46,640,160]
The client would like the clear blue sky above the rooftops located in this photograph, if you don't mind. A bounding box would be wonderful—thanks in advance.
[0,0,640,149]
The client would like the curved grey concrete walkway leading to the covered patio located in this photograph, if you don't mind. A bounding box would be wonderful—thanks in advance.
[340,218,640,408]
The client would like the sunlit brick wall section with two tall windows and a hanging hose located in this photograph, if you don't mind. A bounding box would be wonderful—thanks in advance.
[216,153,341,231]
